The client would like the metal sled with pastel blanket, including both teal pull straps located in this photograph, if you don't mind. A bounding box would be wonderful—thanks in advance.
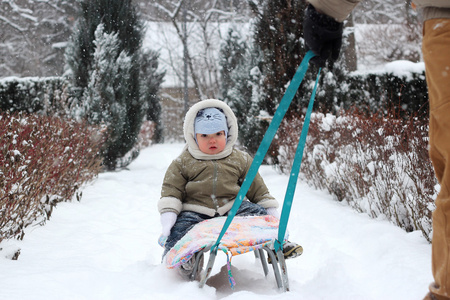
[160,51,321,292]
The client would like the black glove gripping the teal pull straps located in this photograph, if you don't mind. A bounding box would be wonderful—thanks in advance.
[303,4,343,68]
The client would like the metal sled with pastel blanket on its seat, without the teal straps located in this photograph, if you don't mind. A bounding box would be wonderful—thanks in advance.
[166,215,289,291]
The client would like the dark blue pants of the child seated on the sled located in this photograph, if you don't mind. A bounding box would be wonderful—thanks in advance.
[163,201,267,256]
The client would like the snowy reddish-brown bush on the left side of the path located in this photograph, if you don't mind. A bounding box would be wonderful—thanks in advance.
[0,113,104,242]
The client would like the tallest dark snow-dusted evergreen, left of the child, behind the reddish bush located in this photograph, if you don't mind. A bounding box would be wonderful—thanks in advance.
[66,0,145,169]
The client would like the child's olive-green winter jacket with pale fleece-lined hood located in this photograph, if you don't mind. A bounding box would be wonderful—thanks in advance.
[158,99,278,217]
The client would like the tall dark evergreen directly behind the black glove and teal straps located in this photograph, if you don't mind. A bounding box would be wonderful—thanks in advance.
[250,0,351,116]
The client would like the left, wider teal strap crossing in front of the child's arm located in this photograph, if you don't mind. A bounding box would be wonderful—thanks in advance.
[211,51,315,254]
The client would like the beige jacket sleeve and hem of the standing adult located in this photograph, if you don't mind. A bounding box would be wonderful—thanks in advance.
[308,0,450,22]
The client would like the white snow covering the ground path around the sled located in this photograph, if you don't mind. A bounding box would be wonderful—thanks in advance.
[0,144,432,300]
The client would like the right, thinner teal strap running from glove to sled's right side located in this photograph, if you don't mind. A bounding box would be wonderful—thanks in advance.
[275,69,321,251]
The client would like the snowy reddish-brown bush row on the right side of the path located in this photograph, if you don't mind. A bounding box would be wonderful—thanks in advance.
[278,112,437,241]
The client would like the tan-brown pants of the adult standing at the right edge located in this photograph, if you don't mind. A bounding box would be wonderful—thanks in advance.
[422,19,450,299]
